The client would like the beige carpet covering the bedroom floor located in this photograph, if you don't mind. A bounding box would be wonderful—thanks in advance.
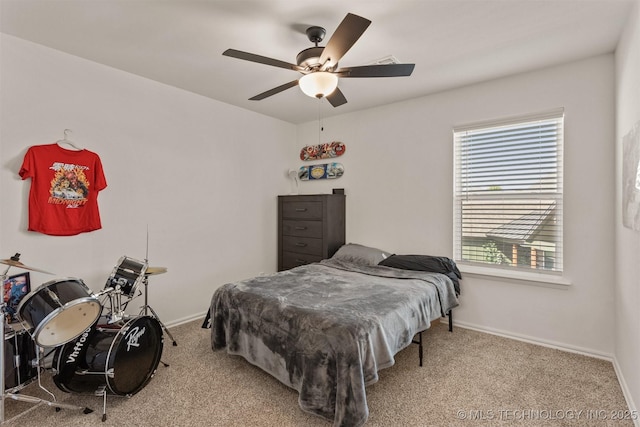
[5,321,633,427]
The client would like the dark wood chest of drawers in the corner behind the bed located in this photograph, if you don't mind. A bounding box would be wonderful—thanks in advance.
[278,194,345,271]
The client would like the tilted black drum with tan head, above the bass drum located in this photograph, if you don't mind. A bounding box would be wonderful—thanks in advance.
[18,278,102,347]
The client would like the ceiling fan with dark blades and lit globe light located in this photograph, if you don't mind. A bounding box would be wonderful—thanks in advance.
[222,13,415,107]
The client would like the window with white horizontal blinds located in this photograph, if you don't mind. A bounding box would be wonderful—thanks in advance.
[453,110,564,273]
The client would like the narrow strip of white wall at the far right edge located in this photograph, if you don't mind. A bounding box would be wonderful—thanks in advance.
[614,3,640,416]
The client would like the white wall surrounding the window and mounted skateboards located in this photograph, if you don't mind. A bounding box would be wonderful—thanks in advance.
[298,55,615,357]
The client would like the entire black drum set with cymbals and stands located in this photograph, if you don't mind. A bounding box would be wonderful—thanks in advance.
[0,254,172,423]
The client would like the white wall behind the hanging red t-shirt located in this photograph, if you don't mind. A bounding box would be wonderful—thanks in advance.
[0,35,295,323]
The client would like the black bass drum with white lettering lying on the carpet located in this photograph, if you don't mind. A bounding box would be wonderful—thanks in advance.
[53,316,163,396]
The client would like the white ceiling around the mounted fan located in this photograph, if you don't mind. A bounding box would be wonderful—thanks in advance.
[0,0,638,123]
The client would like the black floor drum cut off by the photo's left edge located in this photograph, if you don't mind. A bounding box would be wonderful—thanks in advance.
[4,329,38,392]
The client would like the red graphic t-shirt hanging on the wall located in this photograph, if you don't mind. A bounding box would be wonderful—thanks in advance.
[19,144,107,236]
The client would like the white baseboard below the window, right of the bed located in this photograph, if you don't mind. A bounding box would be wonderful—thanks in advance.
[442,319,640,427]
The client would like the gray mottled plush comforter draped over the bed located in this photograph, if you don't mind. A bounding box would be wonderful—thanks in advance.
[210,260,458,426]
